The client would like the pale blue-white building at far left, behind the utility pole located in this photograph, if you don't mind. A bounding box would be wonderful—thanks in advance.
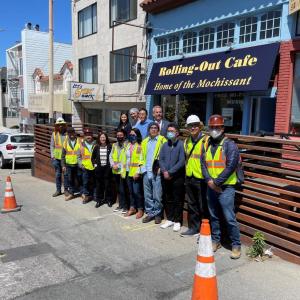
[6,23,72,125]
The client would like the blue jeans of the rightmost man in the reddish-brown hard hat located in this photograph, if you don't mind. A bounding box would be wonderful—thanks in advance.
[208,186,241,246]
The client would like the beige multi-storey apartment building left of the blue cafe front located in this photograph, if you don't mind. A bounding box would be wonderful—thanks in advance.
[71,0,147,125]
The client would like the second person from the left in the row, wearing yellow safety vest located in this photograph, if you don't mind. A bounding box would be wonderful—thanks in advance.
[61,127,80,201]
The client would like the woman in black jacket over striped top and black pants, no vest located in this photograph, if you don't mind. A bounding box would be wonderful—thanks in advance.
[92,132,113,208]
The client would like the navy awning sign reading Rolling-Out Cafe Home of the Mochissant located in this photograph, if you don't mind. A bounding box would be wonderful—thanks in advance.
[145,43,279,95]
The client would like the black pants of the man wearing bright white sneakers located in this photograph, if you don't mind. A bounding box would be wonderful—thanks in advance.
[162,176,185,223]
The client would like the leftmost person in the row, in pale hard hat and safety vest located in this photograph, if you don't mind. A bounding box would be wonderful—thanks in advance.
[50,118,69,197]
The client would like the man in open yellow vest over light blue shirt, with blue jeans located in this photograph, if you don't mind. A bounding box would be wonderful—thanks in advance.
[142,122,167,224]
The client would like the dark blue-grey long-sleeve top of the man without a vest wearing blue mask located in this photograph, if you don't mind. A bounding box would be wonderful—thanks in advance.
[159,140,185,177]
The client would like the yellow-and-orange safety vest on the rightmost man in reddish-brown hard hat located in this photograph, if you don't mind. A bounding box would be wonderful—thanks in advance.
[205,138,237,185]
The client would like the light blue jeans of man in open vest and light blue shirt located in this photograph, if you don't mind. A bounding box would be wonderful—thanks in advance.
[143,173,162,217]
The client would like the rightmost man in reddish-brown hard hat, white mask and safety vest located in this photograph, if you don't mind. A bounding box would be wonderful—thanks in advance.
[201,115,241,259]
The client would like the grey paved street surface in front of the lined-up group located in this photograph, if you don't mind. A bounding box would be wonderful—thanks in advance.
[0,168,300,300]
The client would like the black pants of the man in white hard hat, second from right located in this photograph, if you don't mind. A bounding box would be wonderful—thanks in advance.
[185,177,209,232]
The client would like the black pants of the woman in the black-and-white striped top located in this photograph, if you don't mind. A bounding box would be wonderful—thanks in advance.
[95,166,113,203]
